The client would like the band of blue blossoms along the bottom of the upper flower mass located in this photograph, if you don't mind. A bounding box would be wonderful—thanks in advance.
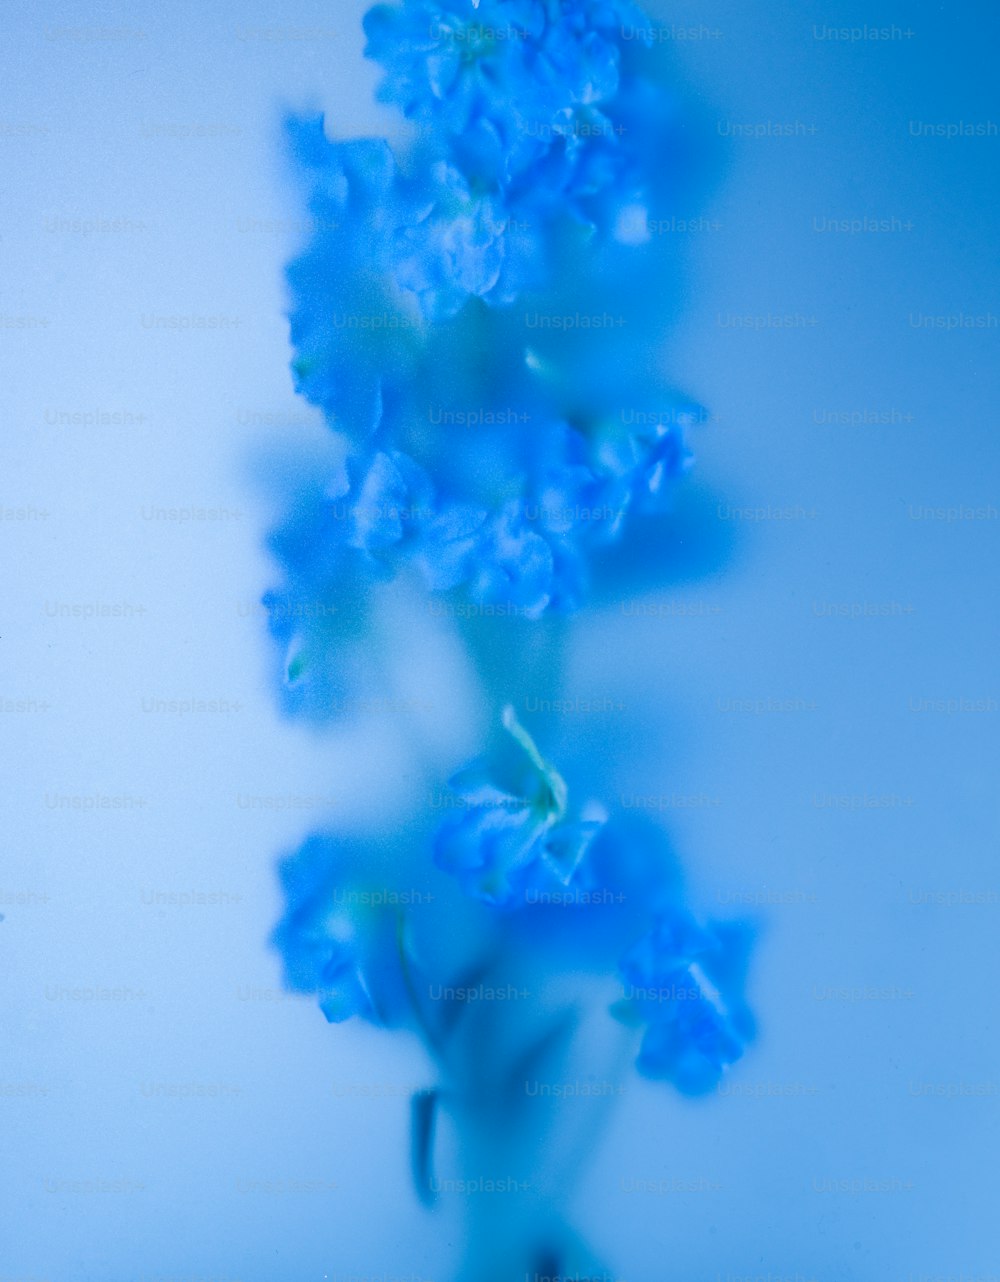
[265,382,687,671]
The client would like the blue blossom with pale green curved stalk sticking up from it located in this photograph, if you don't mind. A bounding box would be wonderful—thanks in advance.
[435,708,603,906]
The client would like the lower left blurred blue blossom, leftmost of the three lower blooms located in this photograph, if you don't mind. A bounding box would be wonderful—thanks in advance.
[272,836,408,1024]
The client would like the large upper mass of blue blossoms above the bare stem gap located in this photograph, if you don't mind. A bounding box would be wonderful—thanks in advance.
[265,0,697,678]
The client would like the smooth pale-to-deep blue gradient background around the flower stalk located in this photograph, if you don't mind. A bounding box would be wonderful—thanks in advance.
[0,0,1000,1282]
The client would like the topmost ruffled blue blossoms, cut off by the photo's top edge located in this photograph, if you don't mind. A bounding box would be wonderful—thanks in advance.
[365,0,665,317]
